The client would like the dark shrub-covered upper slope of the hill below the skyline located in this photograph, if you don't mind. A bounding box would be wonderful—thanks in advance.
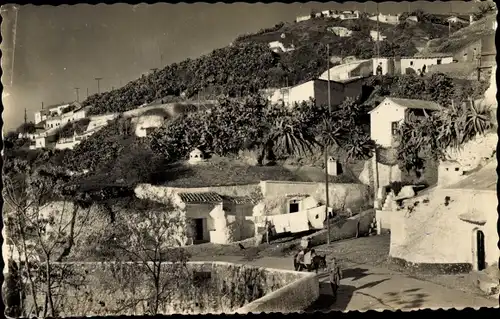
[82,13,468,115]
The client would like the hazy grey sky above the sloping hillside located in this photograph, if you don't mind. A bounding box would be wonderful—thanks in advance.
[1,1,482,131]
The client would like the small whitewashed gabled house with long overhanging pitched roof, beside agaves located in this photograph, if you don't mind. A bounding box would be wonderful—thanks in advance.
[368,97,441,147]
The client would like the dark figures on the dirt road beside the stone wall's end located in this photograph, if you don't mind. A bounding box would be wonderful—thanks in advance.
[295,248,342,301]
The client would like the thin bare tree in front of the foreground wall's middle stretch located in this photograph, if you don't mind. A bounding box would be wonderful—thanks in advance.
[107,199,189,315]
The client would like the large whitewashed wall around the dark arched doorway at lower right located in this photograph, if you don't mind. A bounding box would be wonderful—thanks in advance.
[389,189,499,266]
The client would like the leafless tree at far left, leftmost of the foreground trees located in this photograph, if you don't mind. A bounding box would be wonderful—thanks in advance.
[4,159,90,316]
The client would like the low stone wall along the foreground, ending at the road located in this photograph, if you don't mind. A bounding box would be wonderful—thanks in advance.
[26,262,319,317]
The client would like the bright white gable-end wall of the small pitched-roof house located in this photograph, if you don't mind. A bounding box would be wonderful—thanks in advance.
[370,99,405,147]
